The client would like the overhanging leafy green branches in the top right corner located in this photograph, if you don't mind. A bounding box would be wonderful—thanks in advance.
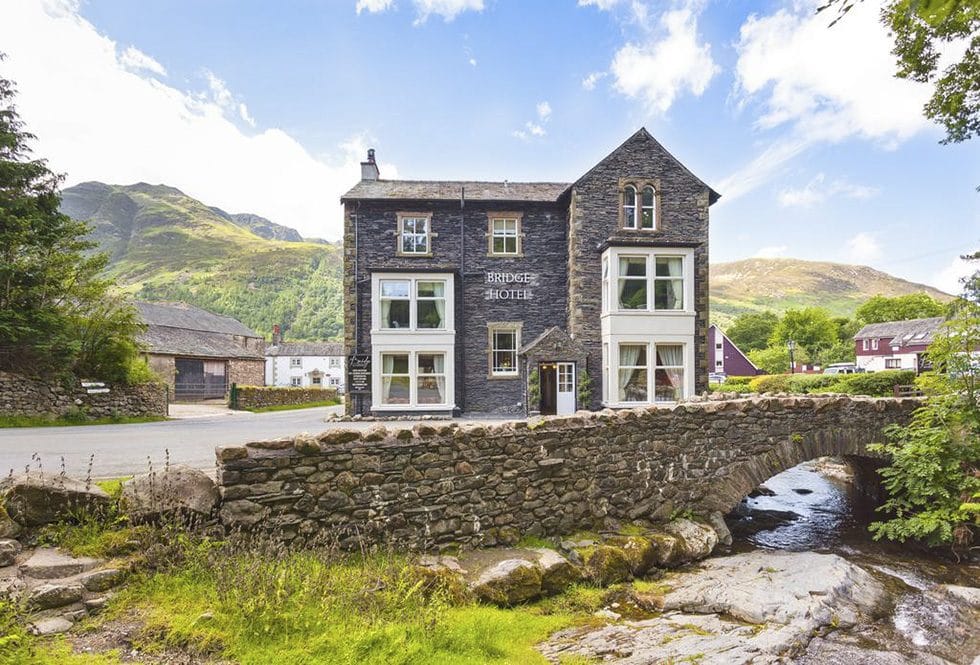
[817,0,980,144]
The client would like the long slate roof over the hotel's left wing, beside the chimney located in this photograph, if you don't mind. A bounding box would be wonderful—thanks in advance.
[340,180,571,203]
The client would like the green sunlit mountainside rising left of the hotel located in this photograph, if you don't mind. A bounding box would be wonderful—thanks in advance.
[61,182,343,340]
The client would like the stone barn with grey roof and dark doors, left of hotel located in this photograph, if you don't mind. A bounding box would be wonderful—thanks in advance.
[137,302,265,401]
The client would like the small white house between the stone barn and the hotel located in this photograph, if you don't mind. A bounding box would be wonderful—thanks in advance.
[265,340,346,392]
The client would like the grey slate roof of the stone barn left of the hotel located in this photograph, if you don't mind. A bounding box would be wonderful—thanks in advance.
[136,302,265,360]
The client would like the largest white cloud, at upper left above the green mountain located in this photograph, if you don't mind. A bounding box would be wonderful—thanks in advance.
[0,0,382,238]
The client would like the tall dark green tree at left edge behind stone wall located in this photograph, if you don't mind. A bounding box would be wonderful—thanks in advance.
[0,64,140,380]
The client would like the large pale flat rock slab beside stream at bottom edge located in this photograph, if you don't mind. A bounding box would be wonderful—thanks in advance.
[540,551,888,665]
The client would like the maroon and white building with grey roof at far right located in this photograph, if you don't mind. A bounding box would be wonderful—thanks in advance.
[854,316,945,372]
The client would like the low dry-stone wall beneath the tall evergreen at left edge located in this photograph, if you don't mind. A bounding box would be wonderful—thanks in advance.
[0,372,167,418]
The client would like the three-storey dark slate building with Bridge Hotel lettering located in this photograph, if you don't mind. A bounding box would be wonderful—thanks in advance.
[341,129,718,415]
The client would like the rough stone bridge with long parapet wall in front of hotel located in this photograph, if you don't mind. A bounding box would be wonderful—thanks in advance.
[217,396,920,549]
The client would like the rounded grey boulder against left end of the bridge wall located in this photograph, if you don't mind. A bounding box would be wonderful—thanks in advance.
[121,465,219,521]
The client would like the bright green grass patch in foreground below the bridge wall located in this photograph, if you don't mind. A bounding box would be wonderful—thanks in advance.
[94,552,591,665]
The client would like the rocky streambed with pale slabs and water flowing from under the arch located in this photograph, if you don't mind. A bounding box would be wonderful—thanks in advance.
[540,461,980,665]
